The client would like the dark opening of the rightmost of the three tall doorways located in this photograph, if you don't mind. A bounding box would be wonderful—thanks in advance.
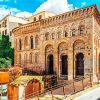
[76,53,84,76]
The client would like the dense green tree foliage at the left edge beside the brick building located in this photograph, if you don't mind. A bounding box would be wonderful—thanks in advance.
[0,35,14,67]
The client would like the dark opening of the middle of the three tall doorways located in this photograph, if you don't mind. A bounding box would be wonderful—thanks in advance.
[61,55,68,75]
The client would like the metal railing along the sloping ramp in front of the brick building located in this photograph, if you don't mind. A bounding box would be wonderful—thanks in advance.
[7,74,100,100]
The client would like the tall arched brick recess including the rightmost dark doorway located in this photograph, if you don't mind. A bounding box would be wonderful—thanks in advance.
[73,39,85,77]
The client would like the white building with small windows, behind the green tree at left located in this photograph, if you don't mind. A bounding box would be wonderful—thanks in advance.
[0,14,28,48]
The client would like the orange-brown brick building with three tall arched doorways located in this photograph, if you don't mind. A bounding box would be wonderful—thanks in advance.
[13,5,100,79]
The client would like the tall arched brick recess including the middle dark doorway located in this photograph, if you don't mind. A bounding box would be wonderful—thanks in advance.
[58,42,68,77]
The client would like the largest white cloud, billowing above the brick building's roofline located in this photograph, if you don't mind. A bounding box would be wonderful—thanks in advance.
[35,0,74,14]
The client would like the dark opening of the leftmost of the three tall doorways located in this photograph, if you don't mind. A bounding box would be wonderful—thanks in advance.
[48,54,54,74]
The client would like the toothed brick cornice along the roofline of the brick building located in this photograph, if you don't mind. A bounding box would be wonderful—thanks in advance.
[13,5,99,34]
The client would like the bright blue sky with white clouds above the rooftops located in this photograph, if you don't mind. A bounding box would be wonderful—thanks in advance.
[0,0,100,19]
